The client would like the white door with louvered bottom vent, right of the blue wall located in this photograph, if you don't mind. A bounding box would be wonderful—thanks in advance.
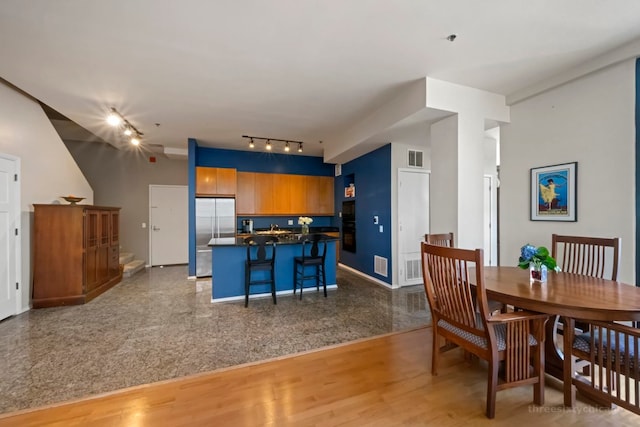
[398,169,430,286]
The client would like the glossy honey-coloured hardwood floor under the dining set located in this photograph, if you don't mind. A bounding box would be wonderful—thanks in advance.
[0,327,640,427]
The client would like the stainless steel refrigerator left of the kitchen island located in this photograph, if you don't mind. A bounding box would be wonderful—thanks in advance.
[196,197,236,277]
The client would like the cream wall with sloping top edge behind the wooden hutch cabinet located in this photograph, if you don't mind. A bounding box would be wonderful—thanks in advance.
[0,80,93,310]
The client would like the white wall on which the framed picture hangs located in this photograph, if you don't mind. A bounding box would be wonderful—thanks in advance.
[500,60,635,283]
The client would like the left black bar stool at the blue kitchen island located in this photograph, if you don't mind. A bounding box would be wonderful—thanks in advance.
[244,236,278,307]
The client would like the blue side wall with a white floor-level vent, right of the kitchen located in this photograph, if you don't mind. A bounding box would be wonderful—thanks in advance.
[335,144,393,284]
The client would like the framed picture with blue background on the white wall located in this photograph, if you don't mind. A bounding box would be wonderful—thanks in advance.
[530,162,578,221]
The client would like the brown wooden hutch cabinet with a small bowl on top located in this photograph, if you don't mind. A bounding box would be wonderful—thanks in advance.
[33,205,122,308]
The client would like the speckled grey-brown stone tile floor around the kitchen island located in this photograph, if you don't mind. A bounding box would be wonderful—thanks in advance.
[0,266,430,413]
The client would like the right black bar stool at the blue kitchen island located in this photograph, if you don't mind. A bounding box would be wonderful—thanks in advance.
[293,234,327,299]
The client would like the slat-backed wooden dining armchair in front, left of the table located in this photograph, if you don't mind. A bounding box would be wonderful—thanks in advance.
[421,242,548,418]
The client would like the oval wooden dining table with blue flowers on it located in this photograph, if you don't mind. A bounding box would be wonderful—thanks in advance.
[470,267,640,380]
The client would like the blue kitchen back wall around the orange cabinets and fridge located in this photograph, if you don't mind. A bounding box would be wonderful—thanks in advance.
[188,138,340,276]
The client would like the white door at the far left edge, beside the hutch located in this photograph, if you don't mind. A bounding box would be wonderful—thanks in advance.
[0,155,20,319]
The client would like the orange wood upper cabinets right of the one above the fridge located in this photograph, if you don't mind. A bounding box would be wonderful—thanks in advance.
[236,172,334,215]
